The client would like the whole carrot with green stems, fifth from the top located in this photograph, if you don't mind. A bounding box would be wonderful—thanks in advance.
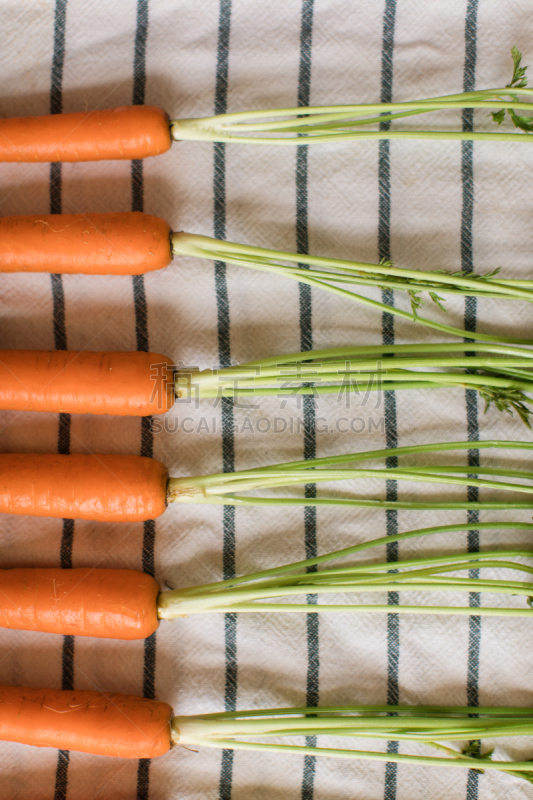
[4,522,533,639]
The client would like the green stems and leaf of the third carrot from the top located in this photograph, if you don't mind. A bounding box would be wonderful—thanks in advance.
[175,343,533,427]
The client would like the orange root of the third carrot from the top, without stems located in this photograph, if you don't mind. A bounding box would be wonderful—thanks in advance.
[0,350,174,416]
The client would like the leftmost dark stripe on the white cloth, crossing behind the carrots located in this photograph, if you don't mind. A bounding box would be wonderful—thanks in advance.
[50,0,70,800]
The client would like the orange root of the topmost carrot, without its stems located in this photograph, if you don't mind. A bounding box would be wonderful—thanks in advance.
[0,106,172,162]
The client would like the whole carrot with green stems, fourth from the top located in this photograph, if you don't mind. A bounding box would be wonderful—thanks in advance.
[0,439,533,522]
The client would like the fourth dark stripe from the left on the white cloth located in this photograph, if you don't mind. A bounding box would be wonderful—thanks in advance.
[296,0,320,800]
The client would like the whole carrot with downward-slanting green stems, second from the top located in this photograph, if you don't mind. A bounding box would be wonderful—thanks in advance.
[0,212,533,344]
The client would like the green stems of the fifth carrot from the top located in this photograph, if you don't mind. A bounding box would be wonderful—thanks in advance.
[158,522,533,619]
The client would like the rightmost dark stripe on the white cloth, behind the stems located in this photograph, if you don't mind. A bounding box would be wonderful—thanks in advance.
[461,0,481,800]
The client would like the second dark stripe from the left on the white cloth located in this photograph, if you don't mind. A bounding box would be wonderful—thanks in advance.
[131,6,156,800]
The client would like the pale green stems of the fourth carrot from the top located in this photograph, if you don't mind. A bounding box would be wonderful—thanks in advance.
[167,440,533,510]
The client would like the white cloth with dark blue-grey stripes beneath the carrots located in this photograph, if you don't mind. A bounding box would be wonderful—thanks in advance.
[0,0,533,800]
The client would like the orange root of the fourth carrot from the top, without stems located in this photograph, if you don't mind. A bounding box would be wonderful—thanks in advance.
[0,453,168,522]
